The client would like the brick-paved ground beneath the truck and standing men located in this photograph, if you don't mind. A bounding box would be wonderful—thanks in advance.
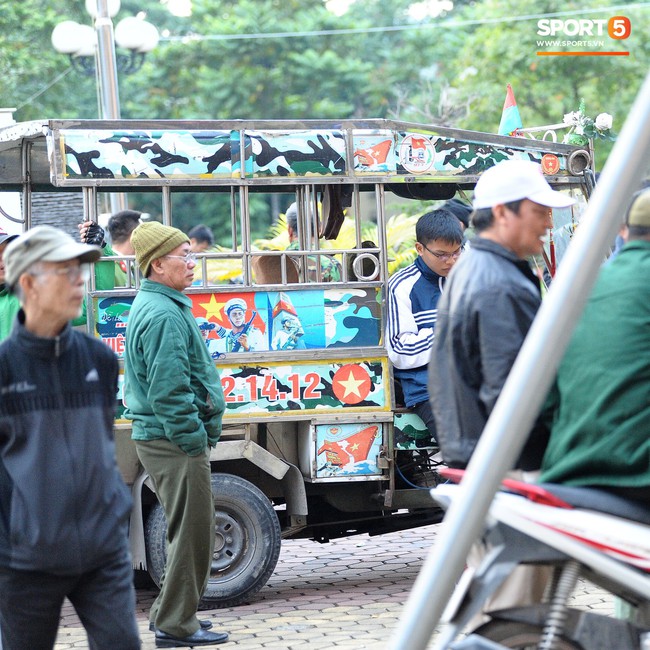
[55,525,613,650]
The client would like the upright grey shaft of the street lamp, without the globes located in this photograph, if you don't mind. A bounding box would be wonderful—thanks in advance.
[95,0,127,214]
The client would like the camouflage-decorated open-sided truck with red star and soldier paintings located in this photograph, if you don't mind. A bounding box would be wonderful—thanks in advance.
[0,120,592,607]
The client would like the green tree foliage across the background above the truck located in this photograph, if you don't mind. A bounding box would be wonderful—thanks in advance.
[0,0,650,234]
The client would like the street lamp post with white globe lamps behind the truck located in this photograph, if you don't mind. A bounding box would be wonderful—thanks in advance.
[52,0,158,213]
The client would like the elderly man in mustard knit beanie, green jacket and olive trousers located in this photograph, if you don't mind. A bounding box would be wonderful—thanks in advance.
[124,222,228,648]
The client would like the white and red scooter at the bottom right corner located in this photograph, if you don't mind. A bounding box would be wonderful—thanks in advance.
[431,469,650,650]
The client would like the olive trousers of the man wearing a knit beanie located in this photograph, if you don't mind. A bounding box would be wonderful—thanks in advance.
[135,440,215,638]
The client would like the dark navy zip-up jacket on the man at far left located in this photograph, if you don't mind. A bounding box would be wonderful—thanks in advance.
[0,312,131,575]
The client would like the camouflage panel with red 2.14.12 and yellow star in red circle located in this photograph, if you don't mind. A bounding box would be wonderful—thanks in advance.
[217,359,390,417]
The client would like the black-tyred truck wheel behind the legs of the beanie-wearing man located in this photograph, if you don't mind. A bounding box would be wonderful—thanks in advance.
[145,474,282,608]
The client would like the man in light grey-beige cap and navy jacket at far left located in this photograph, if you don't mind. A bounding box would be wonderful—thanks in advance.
[0,226,140,650]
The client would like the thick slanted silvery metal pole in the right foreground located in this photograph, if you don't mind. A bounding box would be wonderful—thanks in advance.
[388,74,650,650]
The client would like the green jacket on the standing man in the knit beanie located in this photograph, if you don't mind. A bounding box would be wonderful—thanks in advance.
[124,280,225,456]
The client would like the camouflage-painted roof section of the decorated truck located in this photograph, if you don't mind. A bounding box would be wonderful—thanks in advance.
[0,119,591,192]
